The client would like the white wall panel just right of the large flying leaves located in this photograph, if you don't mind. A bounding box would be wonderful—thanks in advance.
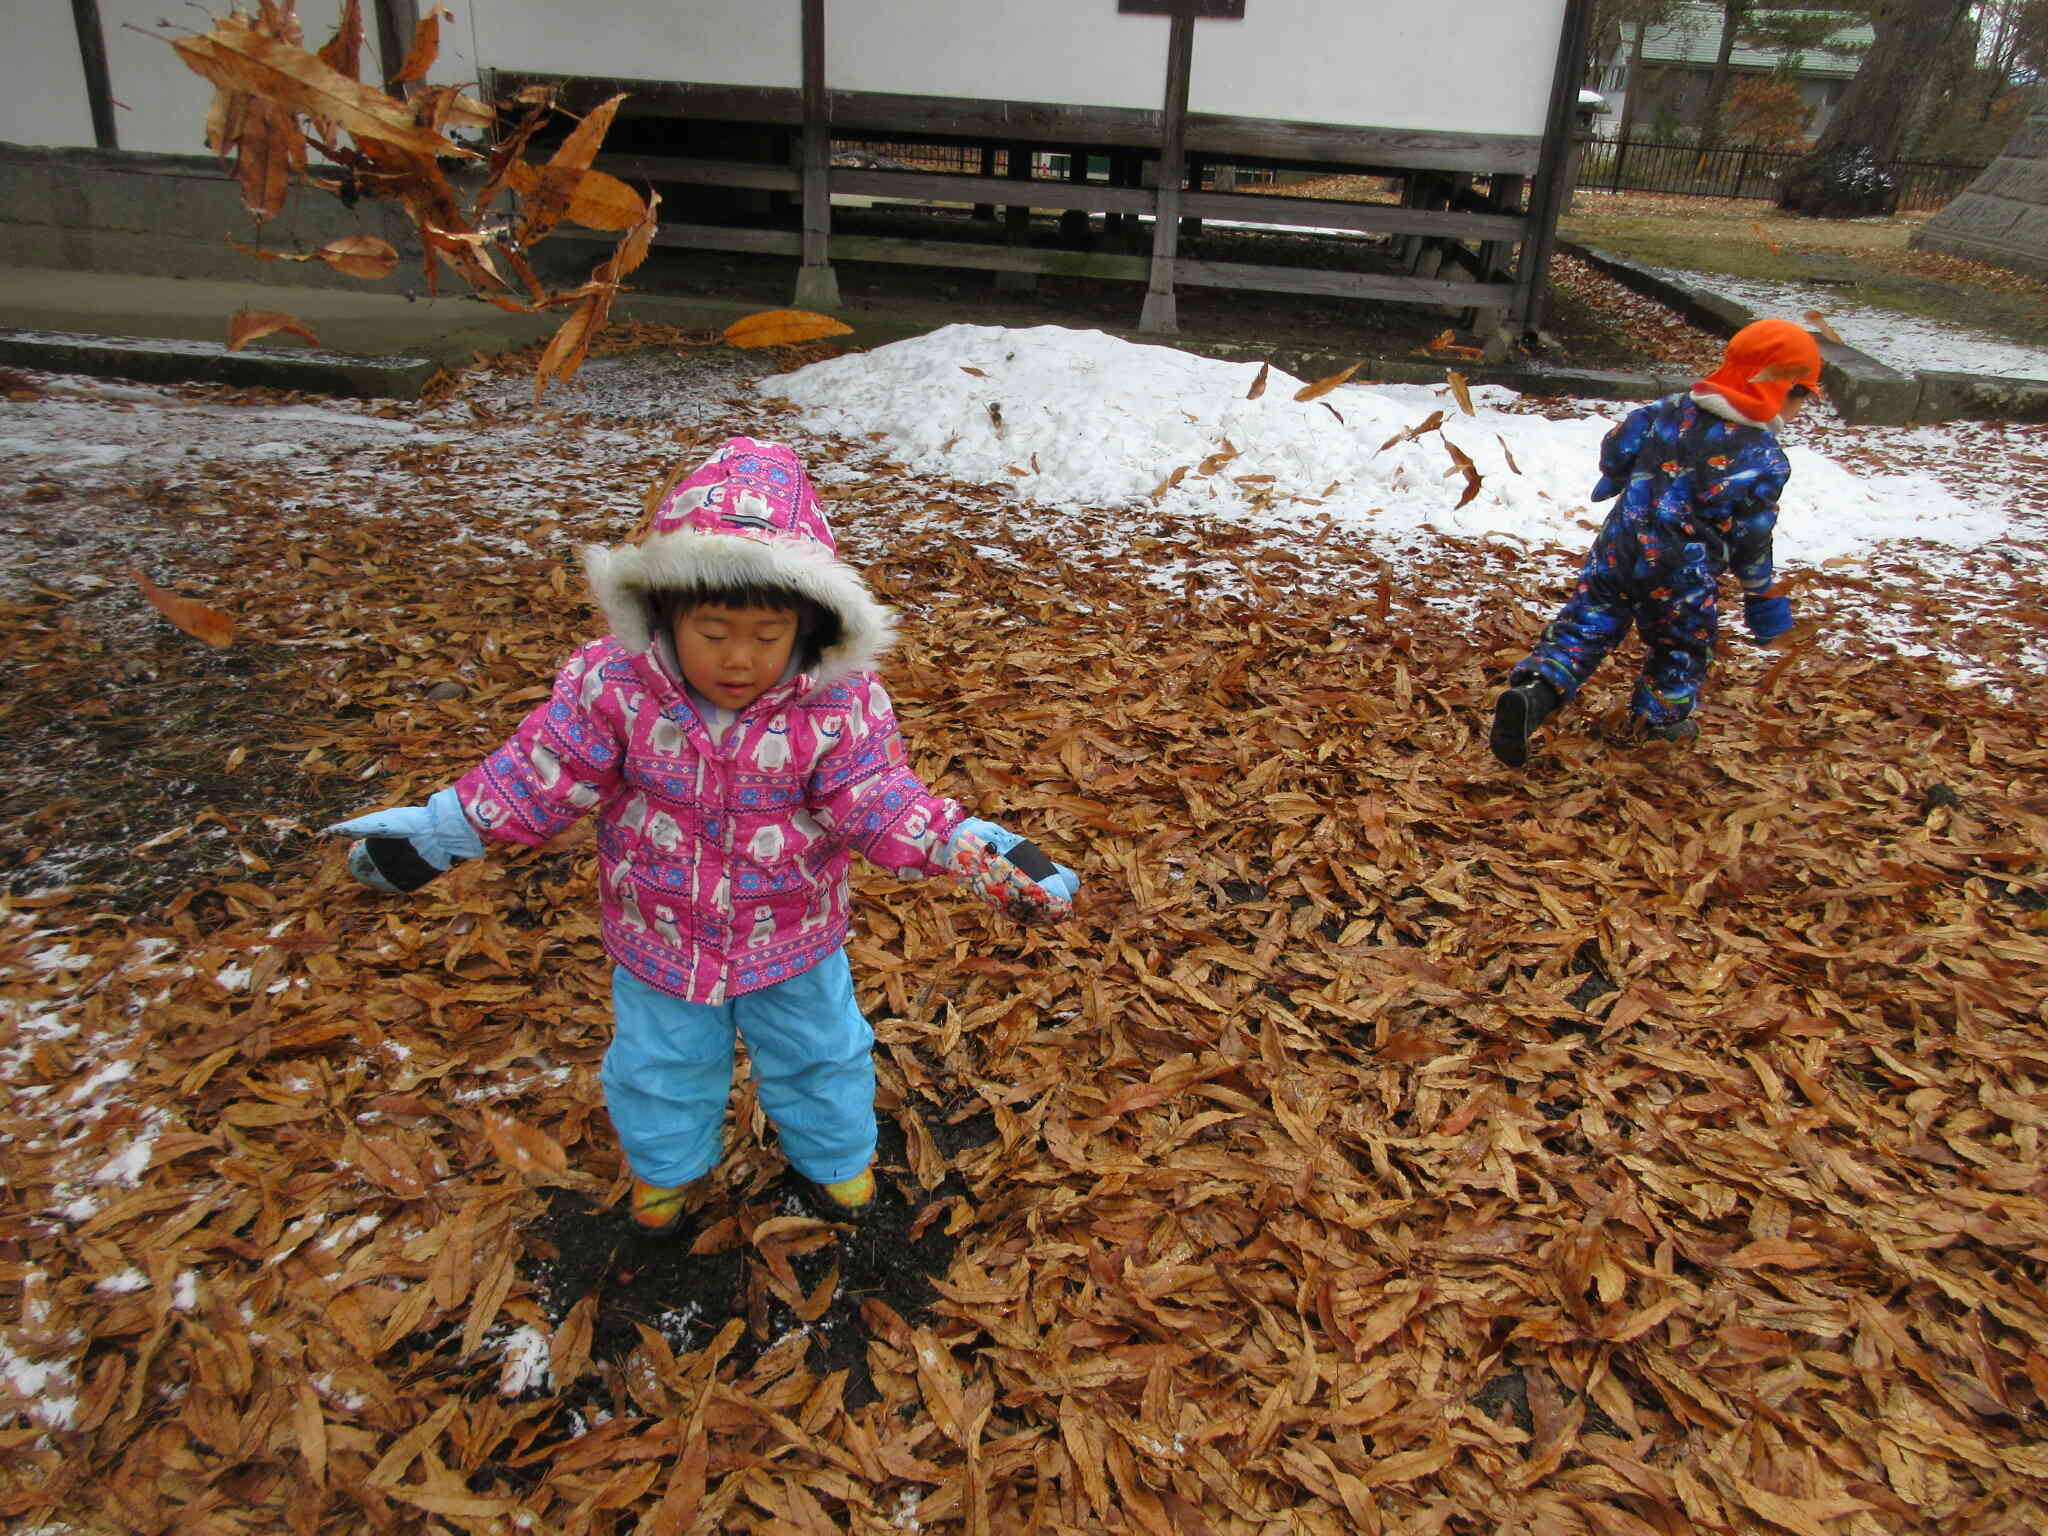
[469,0,798,86]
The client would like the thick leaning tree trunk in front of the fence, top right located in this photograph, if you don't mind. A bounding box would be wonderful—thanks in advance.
[1778,0,1970,219]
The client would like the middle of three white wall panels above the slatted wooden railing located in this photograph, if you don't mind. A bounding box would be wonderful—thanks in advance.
[823,0,1163,111]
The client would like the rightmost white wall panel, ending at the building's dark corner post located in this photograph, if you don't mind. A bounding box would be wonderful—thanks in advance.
[1196,0,1565,133]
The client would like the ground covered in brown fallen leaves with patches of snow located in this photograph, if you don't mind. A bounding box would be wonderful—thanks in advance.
[0,327,2048,1536]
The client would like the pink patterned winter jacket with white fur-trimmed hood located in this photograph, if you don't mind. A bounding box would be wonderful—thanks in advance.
[457,438,963,1004]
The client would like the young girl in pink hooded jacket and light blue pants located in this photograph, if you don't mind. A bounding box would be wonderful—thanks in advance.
[332,438,1079,1231]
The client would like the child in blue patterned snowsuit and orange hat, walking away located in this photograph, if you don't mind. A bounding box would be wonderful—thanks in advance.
[1489,319,1821,768]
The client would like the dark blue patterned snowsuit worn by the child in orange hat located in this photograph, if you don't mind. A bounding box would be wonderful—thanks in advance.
[1509,393,1792,725]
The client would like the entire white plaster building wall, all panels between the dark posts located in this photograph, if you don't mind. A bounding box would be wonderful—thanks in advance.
[0,0,1567,154]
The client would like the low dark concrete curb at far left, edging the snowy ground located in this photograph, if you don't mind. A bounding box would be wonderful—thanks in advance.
[0,330,438,399]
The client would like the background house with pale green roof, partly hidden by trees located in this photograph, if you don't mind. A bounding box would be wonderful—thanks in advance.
[1591,0,1876,139]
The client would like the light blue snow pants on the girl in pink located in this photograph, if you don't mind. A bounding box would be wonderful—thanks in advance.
[602,950,874,1186]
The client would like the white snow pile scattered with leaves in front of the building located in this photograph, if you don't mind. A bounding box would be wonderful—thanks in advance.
[760,326,2005,561]
